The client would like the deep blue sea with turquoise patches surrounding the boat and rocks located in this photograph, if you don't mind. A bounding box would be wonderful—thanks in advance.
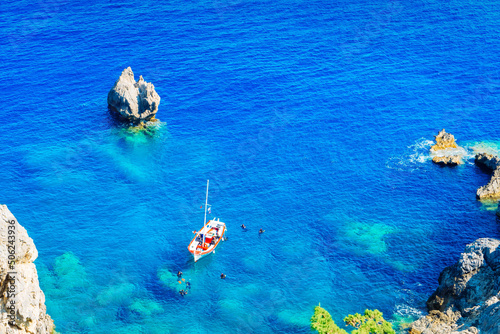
[0,0,500,334]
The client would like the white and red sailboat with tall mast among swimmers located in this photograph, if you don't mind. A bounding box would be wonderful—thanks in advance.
[188,180,226,262]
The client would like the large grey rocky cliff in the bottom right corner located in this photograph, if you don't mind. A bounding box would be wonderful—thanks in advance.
[410,238,500,334]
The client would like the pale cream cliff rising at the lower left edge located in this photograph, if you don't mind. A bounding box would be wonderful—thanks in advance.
[0,205,54,334]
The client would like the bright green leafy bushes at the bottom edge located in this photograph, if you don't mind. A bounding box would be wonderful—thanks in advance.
[311,304,395,334]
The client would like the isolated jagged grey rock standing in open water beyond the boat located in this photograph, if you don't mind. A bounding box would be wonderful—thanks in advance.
[108,67,160,125]
